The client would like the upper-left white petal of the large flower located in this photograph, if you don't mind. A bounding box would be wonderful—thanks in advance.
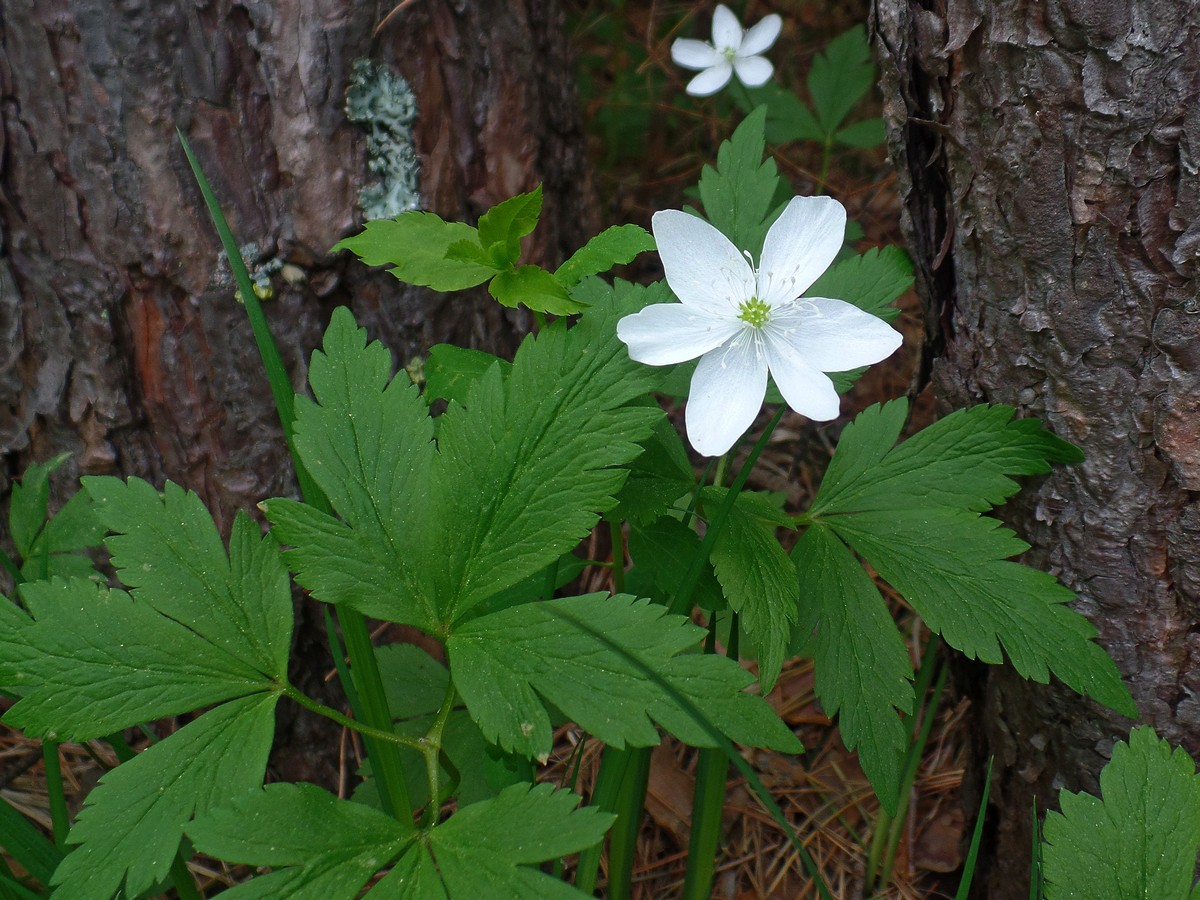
[650,209,755,318]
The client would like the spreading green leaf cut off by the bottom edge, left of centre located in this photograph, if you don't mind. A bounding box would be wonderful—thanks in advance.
[188,785,613,900]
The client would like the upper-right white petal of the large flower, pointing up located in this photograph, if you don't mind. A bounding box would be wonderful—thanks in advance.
[758,197,846,306]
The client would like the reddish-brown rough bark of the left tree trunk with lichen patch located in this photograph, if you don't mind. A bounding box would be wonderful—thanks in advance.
[0,0,593,784]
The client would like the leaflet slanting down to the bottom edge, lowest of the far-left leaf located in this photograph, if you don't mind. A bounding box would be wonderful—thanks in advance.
[54,695,282,900]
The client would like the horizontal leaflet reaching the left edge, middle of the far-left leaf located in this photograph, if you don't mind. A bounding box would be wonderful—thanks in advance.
[0,578,278,740]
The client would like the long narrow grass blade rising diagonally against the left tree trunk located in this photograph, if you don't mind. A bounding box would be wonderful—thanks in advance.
[175,128,414,828]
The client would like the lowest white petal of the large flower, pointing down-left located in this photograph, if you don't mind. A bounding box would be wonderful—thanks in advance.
[684,329,767,456]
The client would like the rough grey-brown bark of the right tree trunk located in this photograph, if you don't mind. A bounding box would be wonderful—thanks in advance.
[872,0,1200,898]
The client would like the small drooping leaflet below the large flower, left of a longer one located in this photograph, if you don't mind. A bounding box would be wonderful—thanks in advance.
[704,488,800,692]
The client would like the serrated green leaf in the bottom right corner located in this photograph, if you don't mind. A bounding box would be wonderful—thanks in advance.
[1043,727,1200,900]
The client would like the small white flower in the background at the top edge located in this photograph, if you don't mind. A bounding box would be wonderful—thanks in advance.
[671,4,784,97]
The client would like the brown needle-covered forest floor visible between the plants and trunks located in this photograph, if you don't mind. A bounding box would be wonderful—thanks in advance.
[0,0,971,900]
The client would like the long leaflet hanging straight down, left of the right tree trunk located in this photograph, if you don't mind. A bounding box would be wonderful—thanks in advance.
[792,528,913,815]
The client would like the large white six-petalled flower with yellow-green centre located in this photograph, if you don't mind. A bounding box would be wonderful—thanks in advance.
[617,197,902,456]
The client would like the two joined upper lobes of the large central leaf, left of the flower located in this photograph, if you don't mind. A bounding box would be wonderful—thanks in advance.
[264,294,662,631]
